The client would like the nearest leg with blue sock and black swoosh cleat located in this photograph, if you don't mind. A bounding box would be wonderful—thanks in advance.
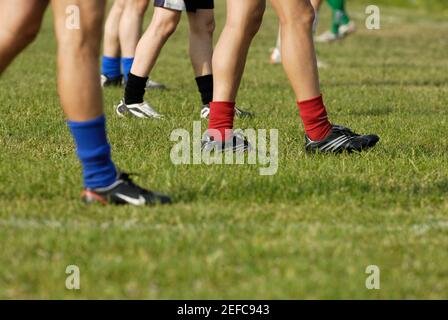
[52,0,170,205]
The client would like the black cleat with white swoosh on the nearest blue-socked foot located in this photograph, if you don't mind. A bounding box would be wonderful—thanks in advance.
[81,172,171,206]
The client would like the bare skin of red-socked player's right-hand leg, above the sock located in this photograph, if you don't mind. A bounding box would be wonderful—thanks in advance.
[271,0,320,101]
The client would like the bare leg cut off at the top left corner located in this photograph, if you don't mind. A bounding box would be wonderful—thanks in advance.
[0,0,48,74]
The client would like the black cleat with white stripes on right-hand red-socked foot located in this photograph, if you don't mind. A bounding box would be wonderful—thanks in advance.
[305,125,380,153]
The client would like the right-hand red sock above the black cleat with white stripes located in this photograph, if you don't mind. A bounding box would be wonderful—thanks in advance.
[297,96,332,141]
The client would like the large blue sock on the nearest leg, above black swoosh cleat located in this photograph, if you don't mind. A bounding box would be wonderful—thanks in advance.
[67,115,117,189]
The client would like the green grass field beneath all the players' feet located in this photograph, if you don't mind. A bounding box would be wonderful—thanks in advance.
[0,1,448,299]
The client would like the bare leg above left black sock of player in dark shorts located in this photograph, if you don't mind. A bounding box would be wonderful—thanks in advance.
[131,7,181,77]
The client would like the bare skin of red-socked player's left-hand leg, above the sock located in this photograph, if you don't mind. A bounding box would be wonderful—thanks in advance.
[213,0,266,102]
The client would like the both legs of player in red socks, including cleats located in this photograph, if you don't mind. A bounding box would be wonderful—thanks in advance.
[203,0,379,152]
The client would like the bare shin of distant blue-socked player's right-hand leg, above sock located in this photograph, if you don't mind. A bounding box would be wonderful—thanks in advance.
[119,0,149,57]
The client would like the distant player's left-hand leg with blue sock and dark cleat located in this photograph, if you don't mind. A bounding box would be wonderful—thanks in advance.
[101,0,126,86]
